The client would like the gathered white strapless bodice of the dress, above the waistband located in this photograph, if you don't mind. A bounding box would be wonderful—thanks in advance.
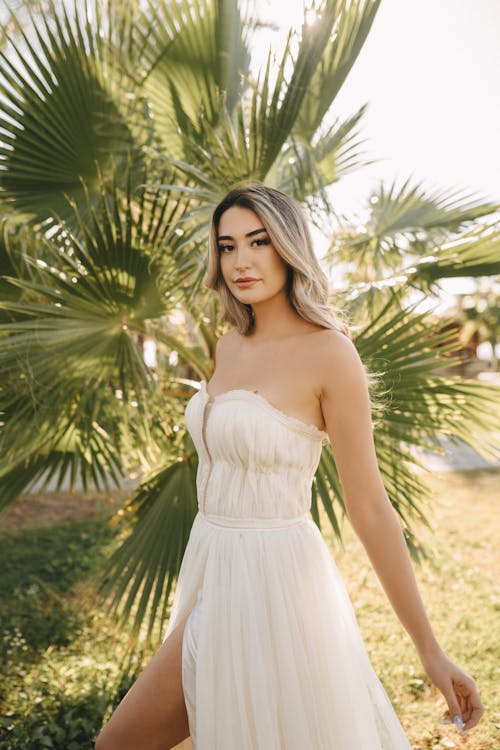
[185,381,327,519]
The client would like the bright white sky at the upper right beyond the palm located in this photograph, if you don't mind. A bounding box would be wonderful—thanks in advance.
[255,0,500,213]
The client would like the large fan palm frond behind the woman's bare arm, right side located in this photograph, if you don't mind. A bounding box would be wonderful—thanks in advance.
[312,297,500,557]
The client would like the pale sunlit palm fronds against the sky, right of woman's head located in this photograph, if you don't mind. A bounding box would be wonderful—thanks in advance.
[328,180,500,296]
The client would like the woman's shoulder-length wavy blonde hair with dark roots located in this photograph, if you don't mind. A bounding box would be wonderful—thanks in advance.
[203,184,349,336]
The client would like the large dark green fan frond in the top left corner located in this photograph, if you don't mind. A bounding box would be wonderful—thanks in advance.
[0,0,145,221]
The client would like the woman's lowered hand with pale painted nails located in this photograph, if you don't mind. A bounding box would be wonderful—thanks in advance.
[420,650,484,732]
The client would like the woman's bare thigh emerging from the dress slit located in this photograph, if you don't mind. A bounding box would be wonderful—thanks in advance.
[96,617,189,750]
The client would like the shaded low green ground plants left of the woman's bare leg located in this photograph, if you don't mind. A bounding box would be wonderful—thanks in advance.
[0,520,124,750]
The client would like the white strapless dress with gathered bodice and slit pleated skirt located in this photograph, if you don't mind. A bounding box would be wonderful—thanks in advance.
[166,381,411,750]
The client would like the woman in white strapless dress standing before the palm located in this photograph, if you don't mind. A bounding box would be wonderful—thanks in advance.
[97,185,483,750]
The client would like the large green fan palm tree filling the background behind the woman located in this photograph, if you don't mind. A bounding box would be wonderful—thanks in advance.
[0,0,498,636]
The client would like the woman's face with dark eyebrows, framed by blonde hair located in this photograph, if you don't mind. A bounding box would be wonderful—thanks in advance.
[217,206,287,305]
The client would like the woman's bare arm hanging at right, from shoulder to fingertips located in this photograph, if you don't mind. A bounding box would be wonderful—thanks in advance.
[319,331,484,730]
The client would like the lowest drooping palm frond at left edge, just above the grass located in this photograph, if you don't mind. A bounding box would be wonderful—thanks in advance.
[0,388,127,513]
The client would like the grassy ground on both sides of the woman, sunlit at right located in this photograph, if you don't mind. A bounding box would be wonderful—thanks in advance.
[0,470,500,750]
